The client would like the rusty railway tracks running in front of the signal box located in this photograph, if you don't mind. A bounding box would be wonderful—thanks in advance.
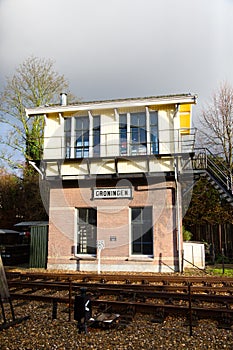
[3,271,233,329]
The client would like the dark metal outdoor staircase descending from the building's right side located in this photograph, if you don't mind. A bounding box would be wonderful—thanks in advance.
[192,148,233,206]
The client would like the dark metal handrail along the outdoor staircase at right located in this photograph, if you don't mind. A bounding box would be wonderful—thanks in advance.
[193,148,233,195]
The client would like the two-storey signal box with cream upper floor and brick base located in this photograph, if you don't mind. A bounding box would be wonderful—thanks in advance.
[26,94,196,272]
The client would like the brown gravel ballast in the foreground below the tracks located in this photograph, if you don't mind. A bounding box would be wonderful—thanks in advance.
[0,301,233,350]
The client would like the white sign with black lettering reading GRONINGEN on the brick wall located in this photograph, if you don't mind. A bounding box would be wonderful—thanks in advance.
[93,187,132,199]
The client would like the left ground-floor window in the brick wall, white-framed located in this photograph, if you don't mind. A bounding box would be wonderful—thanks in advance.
[77,208,97,254]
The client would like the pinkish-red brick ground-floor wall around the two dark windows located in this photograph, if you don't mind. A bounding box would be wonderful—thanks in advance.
[49,181,177,270]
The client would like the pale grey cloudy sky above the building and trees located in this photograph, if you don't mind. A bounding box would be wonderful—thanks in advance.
[0,0,233,159]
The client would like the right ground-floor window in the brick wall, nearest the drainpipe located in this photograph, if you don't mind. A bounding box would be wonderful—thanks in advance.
[131,207,153,255]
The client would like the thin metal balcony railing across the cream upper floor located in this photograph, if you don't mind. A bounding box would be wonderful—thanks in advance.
[43,129,196,160]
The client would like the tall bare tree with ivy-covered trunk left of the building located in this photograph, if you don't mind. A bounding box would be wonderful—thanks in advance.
[0,56,74,166]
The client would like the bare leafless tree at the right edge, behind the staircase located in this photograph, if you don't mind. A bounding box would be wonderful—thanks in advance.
[200,82,233,171]
